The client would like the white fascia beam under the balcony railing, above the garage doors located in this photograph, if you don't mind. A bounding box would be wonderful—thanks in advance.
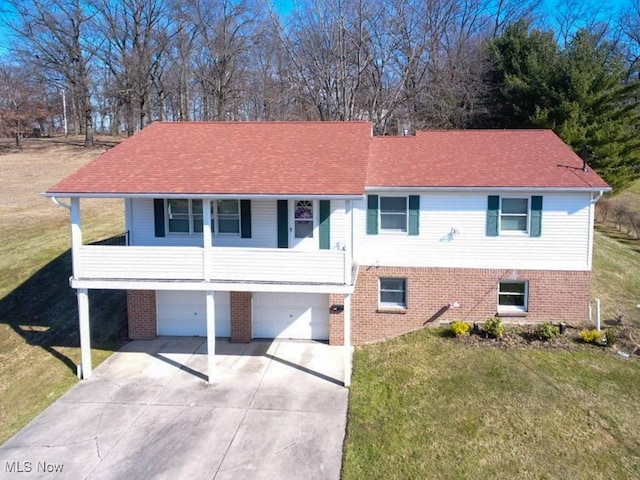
[69,278,355,294]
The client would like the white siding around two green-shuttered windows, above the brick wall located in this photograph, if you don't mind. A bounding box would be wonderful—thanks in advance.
[354,191,591,270]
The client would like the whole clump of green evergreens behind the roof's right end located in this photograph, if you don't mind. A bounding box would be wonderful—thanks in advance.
[484,22,640,191]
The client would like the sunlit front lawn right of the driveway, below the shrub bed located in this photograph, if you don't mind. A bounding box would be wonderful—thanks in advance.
[343,330,640,480]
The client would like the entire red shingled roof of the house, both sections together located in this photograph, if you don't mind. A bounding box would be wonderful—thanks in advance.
[47,122,607,196]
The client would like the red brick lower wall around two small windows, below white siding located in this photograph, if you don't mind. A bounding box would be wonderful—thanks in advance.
[336,266,591,345]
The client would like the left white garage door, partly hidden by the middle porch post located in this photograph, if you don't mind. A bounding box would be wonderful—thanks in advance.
[156,290,231,337]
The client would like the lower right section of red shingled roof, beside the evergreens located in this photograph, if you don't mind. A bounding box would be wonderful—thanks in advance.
[367,130,607,188]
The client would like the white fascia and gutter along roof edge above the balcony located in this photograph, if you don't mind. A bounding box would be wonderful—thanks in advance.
[41,192,364,200]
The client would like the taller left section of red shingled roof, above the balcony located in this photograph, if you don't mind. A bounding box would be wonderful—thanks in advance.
[47,122,371,195]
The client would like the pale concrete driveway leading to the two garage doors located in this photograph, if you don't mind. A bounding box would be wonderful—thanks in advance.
[0,337,348,480]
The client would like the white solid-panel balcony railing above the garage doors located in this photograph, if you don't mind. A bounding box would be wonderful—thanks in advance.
[74,245,351,284]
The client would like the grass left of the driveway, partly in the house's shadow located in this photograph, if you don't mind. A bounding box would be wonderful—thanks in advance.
[0,137,126,444]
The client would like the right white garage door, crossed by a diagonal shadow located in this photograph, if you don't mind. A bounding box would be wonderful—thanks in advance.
[253,293,329,340]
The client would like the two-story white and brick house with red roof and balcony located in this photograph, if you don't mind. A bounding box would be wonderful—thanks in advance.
[46,122,609,384]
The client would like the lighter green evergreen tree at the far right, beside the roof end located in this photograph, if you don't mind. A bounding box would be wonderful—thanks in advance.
[557,30,640,191]
